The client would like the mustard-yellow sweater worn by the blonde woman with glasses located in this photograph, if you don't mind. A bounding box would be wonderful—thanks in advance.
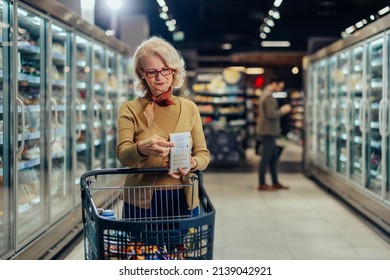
[116,96,210,209]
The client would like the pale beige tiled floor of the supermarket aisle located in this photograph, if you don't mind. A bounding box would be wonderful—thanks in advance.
[65,144,390,260]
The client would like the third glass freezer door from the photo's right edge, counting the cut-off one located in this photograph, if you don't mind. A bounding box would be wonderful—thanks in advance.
[348,46,364,185]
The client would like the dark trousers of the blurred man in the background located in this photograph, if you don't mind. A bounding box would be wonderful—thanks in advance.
[259,135,280,185]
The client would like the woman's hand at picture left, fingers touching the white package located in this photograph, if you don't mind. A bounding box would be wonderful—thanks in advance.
[138,135,175,157]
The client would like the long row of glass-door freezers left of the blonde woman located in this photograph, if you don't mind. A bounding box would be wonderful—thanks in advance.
[0,1,129,259]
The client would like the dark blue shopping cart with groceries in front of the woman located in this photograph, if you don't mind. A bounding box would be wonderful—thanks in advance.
[80,168,215,260]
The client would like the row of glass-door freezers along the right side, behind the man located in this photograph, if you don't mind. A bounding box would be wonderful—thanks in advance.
[304,16,390,235]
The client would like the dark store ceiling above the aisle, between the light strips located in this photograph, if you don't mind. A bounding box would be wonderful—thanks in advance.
[96,0,390,67]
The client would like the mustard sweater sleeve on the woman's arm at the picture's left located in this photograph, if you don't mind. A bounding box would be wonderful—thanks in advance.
[116,103,144,167]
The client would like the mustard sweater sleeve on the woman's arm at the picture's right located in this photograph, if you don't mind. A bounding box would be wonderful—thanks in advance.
[191,104,210,171]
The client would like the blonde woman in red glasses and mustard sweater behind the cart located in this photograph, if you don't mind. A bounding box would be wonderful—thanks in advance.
[116,36,210,218]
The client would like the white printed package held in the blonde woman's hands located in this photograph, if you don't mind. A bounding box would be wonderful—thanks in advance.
[169,132,192,172]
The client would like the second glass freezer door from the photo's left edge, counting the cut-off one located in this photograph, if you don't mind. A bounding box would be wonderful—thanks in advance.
[15,8,47,245]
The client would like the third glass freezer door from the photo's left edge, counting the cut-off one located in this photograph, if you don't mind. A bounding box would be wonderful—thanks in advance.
[49,24,72,222]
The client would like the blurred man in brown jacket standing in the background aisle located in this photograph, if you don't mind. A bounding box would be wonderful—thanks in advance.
[256,77,291,191]
